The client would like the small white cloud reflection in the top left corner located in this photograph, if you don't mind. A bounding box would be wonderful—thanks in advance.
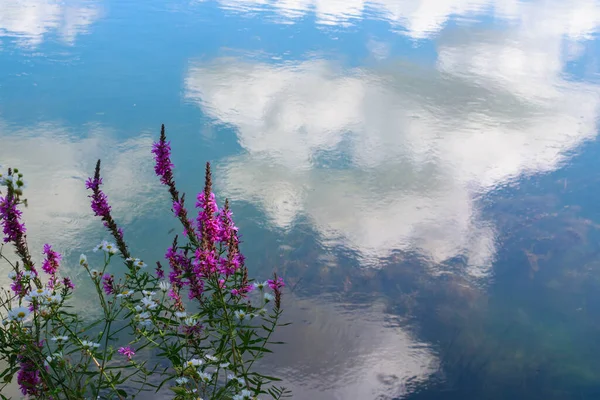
[0,0,101,47]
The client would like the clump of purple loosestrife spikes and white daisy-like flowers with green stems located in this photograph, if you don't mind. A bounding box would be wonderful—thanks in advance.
[0,125,289,400]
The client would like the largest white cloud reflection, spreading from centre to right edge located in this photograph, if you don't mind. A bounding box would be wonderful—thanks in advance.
[186,2,600,276]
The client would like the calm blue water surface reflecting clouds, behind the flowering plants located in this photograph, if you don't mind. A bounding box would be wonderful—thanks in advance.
[0,0,600,400]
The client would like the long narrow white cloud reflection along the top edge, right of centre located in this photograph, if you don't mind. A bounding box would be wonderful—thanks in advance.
[199,0,600,38]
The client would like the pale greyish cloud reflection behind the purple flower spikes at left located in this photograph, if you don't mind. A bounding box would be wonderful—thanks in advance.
[0,120,157,255]
